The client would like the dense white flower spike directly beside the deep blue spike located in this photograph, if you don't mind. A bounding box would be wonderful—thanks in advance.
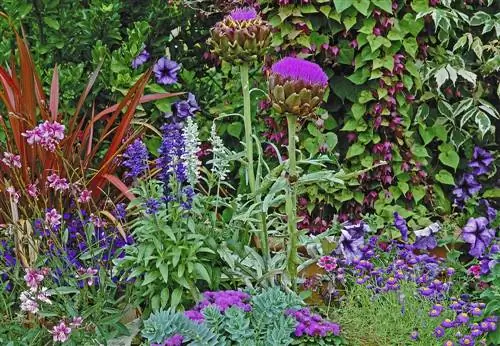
[181,118,201,187]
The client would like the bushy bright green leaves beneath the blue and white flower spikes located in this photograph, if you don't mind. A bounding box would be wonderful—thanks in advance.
[116,179,221,311]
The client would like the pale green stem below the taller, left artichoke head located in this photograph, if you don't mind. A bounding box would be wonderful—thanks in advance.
[240,64,255,193]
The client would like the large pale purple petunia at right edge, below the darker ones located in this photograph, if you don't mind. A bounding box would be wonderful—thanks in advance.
[462,217,495,257]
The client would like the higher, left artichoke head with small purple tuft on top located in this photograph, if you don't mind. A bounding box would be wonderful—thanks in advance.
[208,8,271,65]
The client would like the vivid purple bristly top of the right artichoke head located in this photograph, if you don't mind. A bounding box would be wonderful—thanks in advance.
[271,57,328,87]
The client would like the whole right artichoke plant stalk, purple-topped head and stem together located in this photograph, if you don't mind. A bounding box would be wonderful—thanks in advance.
[269,57,328,289]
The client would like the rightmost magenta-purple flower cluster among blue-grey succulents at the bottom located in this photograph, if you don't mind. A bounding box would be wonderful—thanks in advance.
[285,308,340,337]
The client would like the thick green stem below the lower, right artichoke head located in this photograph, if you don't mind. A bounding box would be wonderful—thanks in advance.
[286,114,298,290]
